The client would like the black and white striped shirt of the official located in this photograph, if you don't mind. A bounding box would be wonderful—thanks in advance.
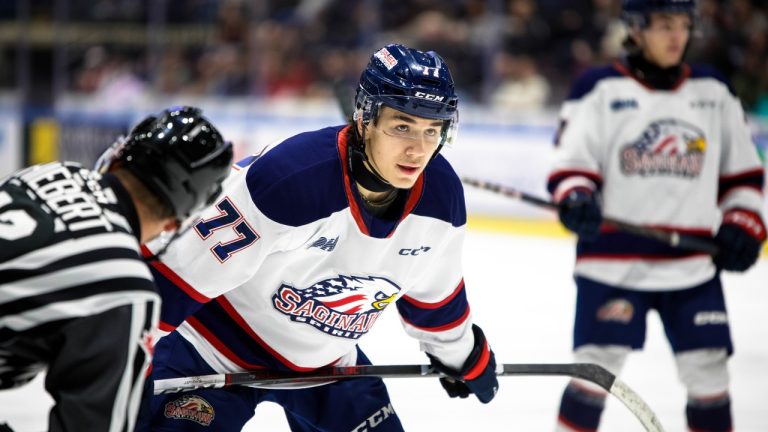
[0,162,160,431]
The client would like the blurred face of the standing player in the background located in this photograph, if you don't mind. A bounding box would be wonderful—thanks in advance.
[640,13,691,68]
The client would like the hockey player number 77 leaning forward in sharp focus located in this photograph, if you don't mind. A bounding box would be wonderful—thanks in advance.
[136,45,497,431]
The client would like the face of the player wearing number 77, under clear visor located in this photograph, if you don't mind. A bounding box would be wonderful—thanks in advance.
[365,107,443,189]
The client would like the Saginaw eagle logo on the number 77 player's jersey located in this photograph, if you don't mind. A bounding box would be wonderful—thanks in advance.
[272,275,400,339]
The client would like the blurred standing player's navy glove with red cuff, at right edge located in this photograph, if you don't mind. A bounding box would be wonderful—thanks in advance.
[714,209,766,271]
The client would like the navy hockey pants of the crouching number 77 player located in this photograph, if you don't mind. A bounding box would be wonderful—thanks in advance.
[136,332,403,432]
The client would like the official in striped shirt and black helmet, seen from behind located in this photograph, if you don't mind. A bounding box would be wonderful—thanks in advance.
[0,107,232,432]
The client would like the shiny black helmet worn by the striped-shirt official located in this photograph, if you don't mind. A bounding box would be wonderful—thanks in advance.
[96,106,233,220]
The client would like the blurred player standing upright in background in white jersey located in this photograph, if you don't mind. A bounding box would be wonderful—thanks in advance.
[548,0,766,431]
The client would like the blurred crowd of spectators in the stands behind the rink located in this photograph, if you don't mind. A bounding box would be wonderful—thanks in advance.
[0,0,768,115]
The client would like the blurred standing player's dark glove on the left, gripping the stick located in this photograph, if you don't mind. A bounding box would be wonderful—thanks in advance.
[558,189,603,240]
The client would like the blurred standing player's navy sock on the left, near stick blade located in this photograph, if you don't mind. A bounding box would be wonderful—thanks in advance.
[558,383,606,432]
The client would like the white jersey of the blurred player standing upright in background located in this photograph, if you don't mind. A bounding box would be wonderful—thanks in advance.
[548,62,764,290]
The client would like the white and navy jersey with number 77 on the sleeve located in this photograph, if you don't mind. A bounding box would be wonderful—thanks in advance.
[145,127,474,372]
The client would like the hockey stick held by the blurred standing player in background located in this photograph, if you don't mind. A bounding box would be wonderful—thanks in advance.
[461,177,718,256]
